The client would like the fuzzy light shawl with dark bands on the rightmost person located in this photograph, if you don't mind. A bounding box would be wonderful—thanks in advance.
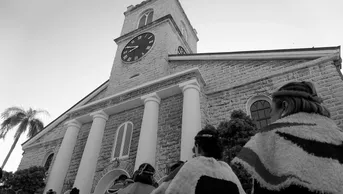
[232,113,343,193]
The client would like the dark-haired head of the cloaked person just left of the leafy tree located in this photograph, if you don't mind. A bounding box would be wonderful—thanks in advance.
[194,125,223,160]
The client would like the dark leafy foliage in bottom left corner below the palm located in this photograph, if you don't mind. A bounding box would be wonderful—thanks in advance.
[0,166,45,194]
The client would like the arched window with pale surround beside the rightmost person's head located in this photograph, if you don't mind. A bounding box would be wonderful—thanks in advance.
[247,95,271,129]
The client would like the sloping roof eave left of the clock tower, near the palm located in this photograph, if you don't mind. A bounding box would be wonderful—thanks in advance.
[21,80,109,149]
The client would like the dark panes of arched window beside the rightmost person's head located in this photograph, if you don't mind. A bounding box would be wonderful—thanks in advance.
[250,100,271,129]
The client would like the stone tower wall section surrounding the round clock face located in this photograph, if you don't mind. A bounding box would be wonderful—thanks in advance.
[106,21,188,96]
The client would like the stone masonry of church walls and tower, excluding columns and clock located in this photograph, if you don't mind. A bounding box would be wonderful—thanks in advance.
[18,0,343,193]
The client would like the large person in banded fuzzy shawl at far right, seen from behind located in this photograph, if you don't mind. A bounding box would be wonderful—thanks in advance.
[232,82,343,194]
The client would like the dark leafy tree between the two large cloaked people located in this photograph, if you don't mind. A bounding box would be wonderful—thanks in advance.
[217,110,257,193]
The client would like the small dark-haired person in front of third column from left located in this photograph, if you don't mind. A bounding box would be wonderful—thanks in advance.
[118,163,156,194]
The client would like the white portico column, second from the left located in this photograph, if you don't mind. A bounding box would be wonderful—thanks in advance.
[74,111,108,194]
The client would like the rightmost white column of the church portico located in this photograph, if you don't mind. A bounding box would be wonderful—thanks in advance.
[179,80,201,161]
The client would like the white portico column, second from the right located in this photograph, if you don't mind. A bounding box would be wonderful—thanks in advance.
[134,93,161,170]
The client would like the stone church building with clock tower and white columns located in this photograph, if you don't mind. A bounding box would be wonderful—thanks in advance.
[19,0,343,194]
